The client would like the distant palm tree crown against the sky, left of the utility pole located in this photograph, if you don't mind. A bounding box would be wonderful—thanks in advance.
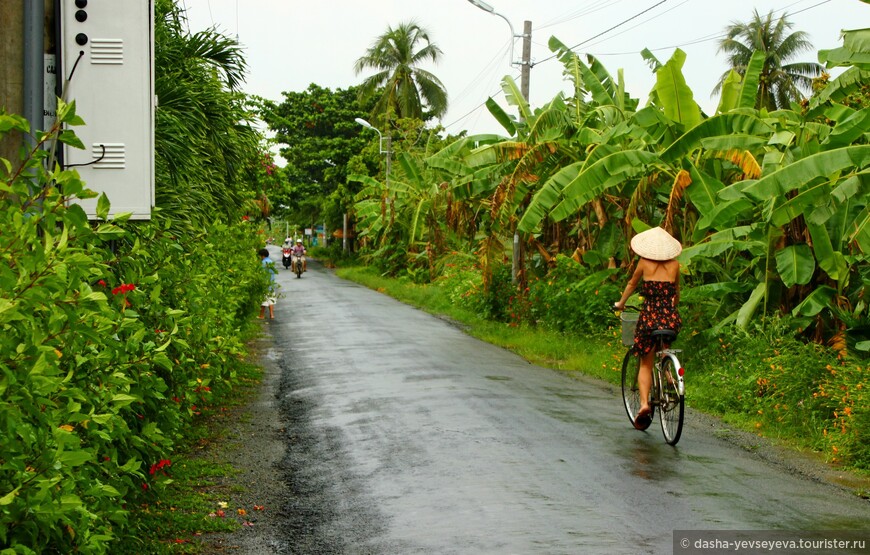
[354,21,447,120]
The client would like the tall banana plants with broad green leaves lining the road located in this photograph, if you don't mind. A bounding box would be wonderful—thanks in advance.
[352,28,870,356]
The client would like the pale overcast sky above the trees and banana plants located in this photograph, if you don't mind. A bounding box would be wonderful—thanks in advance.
[180,0,870,138]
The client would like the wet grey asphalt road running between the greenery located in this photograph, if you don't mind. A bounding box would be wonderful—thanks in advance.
[270,253,870,555]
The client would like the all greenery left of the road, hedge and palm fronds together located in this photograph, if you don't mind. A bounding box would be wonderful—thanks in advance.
[0,0,268,553]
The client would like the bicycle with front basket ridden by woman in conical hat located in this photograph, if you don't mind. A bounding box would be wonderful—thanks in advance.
[619,309,686,445]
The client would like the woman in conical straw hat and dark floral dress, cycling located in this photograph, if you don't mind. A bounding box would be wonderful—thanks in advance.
[614,227,683,426]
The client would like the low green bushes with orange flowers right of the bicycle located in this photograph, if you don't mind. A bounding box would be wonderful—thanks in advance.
[681,318,870,468]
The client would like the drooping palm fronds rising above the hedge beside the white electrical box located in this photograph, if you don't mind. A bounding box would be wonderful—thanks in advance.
[154,0,261,226]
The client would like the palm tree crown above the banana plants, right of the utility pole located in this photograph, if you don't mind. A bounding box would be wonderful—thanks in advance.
[713,10,823,110]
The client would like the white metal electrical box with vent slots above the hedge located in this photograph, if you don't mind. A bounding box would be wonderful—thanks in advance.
[57,0,155,220]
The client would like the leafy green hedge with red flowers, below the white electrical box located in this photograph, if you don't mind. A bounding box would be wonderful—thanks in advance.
[0,107,266,554]
